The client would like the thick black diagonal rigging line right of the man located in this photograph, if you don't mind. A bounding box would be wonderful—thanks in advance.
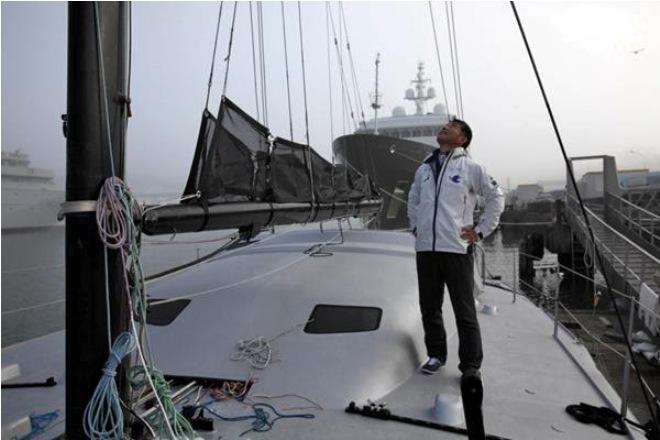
[510,1,658,427]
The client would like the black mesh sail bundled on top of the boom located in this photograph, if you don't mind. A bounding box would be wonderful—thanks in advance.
[184,97,380,204]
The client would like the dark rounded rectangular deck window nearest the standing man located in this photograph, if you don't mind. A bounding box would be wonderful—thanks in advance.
[305,304,383,334]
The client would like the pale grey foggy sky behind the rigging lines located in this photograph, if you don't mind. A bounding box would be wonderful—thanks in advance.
[1,2,660,193]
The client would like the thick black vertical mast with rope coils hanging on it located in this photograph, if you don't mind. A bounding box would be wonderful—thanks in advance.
[65,2,130,438]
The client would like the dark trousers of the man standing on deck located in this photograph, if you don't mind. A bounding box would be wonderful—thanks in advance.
[417,252,483,372]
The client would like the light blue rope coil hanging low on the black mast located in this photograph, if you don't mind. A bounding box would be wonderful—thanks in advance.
[83,332,135,440]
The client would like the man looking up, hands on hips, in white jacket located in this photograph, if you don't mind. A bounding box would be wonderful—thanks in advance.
[408,119,504,374]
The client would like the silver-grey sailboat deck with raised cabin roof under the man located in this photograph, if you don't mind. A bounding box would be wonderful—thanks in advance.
[2,228,642,440]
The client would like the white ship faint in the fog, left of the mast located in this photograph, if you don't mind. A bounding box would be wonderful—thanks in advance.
[2,150,65,231]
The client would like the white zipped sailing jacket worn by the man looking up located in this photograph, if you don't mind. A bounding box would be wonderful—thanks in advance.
[408,148,504,254]
